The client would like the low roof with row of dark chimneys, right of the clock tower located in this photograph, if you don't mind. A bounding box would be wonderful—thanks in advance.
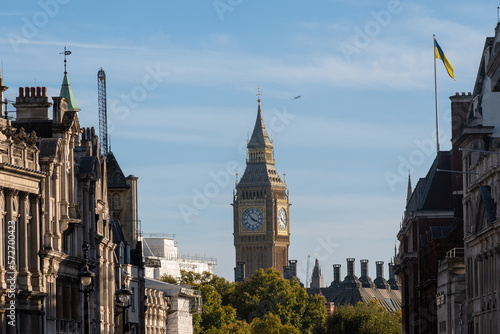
[307,258,401,312]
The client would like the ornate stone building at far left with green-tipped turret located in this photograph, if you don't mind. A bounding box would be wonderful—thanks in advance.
[0,68,115,333]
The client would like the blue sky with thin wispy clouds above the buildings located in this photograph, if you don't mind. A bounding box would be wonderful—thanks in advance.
[0,0,498,284]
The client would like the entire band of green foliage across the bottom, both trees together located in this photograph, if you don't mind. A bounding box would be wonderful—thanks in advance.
[161,268,402,334]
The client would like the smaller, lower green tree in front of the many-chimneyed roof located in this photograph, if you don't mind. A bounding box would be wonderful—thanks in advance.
[327,300,402,334]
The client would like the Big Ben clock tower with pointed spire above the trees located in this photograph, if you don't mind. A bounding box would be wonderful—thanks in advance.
[232,91,290,280]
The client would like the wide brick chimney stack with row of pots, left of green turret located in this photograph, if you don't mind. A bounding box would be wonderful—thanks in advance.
[13,87,52,121]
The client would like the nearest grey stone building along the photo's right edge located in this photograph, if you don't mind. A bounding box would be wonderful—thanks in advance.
[451,24,500,334]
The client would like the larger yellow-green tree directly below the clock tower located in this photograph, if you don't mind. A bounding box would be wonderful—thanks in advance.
[162,268,326,334]
